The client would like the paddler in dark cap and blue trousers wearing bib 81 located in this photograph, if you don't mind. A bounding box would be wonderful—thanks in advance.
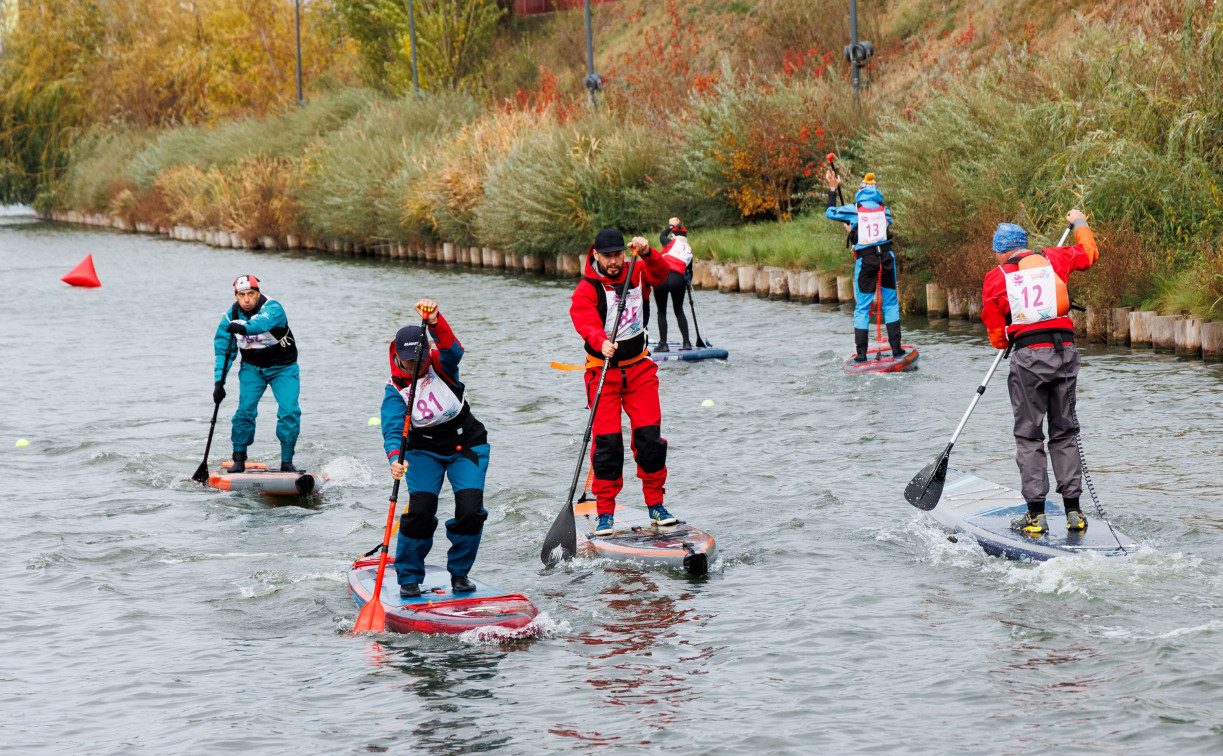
[382,300,488,598]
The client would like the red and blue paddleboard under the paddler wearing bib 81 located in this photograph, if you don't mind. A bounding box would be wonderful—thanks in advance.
[349,555,539,634]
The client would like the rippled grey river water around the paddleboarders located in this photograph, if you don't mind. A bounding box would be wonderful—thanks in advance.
[0,215,1223,755]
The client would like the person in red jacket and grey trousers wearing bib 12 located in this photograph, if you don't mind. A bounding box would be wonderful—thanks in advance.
[981,210,1099,537]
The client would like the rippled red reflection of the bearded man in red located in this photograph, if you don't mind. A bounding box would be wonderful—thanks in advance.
[552,569,717,743]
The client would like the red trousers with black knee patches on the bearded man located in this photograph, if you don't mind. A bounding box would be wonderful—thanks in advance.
[586,357,667,515]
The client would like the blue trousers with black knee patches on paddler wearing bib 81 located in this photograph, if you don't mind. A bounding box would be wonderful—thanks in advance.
[395,444,488,585]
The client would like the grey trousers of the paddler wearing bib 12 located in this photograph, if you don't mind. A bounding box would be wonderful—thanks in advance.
[1007,345,1082,502]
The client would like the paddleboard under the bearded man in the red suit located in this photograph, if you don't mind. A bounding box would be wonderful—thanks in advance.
[574,500,718,575]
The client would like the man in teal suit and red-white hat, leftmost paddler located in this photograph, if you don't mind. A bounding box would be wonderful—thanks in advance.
[213,270,302,472]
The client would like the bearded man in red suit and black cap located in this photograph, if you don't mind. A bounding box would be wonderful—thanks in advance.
[569,229,676,536]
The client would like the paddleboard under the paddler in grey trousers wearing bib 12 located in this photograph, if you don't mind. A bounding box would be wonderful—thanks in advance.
[929,470,1139,561]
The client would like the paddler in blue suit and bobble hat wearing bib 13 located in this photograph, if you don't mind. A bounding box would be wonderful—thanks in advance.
[824,170,905,362]
